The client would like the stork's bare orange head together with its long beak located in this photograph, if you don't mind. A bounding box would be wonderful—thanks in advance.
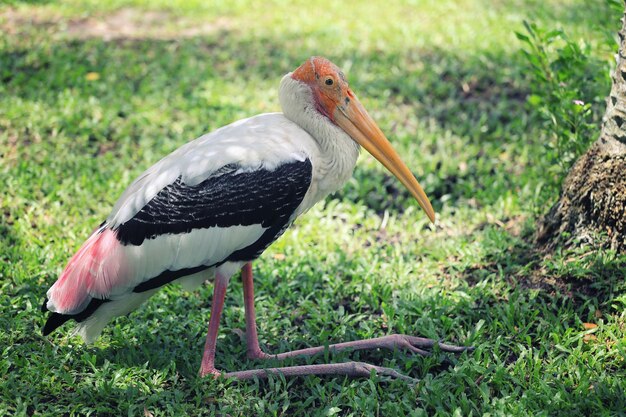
[291,57,435,222]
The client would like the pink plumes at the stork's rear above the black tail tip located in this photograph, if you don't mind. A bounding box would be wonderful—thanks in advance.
[47,226,127,314]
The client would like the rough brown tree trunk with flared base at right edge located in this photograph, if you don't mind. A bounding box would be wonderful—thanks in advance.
[537,10,626,252]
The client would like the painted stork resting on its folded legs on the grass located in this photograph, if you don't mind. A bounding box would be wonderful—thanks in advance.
[43,57,466,378]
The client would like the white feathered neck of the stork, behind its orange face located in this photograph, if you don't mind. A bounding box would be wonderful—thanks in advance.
[279,73,360,194]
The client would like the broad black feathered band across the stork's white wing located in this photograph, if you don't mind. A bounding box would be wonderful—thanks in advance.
[117,159,312,245]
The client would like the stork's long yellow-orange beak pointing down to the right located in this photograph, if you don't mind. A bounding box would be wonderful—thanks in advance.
[333,94,435,223]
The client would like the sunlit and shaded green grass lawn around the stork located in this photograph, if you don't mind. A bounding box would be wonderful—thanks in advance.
[0,0,626,416]
